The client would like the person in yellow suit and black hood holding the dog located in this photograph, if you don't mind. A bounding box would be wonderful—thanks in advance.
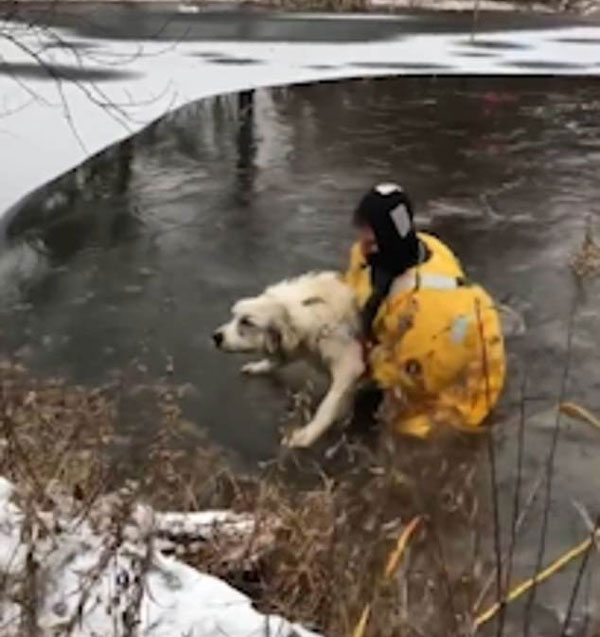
[346,184,506,437]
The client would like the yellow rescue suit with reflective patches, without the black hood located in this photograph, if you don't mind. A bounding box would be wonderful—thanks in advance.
[346,189,506,437]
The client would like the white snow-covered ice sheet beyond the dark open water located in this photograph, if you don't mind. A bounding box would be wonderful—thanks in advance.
[0,15,600,216]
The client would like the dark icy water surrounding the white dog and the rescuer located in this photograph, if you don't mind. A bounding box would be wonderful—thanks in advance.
[0,77,600,635]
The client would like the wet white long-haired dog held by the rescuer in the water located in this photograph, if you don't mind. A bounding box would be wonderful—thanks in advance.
[213,272,365,447]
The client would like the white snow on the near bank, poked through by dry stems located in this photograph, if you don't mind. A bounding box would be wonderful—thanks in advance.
[0,478,322,637]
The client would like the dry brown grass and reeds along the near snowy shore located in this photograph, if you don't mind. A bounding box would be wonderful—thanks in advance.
[0,360,598,637]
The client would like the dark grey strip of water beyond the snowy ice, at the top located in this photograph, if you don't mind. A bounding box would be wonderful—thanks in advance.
[0,0,597,43]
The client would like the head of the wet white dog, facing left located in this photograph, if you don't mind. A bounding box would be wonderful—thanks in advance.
[213,296,299,356]
